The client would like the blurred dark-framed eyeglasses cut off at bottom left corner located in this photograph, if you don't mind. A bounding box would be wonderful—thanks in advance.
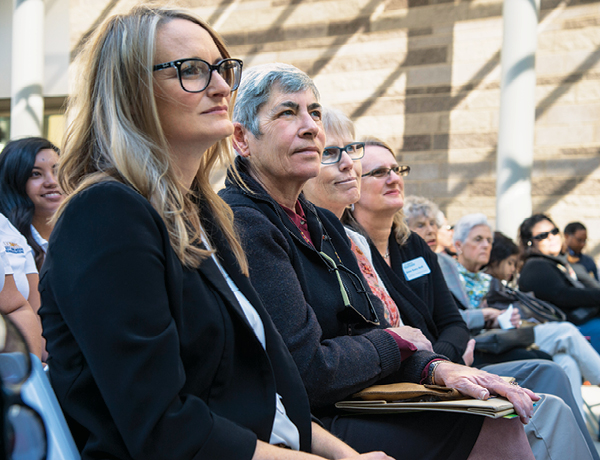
[0,316,48,460]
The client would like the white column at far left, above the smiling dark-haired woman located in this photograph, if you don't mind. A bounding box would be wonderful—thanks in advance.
[10,0,44,139]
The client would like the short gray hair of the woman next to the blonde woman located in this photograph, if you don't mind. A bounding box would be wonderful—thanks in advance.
[233,62,320,137]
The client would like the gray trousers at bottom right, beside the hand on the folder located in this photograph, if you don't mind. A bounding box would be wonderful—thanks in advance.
[482,360,600,460]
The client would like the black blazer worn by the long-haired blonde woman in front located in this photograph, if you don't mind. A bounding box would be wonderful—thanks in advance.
[40,182,311,459]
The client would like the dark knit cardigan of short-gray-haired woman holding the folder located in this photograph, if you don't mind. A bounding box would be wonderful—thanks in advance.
[221,157,437,410]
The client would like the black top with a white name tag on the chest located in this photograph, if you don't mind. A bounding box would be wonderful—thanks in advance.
[370,232,470,364]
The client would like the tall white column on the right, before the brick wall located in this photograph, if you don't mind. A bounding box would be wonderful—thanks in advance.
[496,0,540,238]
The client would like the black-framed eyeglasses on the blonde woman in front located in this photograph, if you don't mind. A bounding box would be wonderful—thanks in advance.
[152,58,244,93]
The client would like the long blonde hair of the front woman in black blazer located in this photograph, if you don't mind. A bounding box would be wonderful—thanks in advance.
[56,5,248,275]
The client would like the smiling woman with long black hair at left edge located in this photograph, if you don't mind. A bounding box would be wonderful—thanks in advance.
[0,137,64,270]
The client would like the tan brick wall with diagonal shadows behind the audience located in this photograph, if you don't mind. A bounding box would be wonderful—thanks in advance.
[71,0,600,256]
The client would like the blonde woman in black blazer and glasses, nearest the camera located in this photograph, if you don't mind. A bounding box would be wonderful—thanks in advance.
[40,5,389,460]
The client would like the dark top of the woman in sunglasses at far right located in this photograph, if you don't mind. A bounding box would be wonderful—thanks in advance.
[519,254,600,324]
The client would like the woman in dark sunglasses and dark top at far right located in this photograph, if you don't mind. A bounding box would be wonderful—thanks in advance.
[519,214,600,353]
